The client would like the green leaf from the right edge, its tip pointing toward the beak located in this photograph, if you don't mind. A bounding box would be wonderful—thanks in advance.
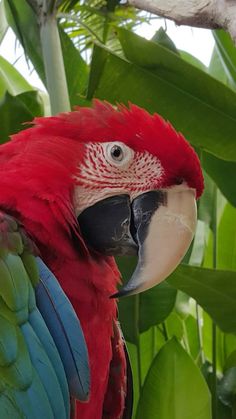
[168,265,236,333]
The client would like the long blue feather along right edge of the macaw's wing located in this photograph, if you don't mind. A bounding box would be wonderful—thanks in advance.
[35,258,90,401]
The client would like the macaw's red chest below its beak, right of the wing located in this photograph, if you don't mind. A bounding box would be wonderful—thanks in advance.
[45,254,125,419]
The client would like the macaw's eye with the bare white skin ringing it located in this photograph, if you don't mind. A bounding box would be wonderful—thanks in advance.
[104,141,134,169]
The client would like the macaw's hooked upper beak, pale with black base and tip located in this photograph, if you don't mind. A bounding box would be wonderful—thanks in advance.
[113,187,197,297]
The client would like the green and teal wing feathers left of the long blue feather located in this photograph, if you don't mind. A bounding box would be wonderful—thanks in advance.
[0,214,69,419]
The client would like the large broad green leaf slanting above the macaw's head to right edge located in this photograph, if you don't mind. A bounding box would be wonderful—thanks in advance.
[91,29,236,161]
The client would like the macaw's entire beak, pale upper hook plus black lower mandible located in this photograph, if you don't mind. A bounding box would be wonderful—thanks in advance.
[79,185,197,297]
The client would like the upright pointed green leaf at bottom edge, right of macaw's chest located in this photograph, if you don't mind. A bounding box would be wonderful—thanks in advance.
[136,339,211,419]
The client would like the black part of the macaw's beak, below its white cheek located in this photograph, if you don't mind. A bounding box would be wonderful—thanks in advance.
[78,191,166,256]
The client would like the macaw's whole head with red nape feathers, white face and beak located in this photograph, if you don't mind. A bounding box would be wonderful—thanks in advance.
[0,100,203,296]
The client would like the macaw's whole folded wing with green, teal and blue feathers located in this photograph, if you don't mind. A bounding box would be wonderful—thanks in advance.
[0,211,90,419]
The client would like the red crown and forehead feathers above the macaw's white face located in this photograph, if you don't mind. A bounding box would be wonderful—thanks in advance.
[30,100,203,197]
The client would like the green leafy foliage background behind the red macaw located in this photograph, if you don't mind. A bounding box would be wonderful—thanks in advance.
[0,0,236,419]
